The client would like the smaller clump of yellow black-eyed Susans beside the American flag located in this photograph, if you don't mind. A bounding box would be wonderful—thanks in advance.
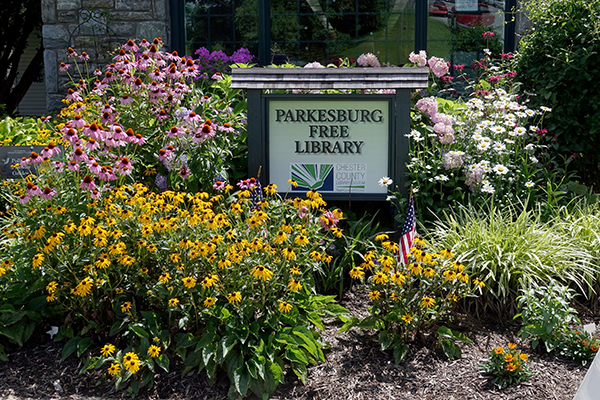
[341,234,485,363]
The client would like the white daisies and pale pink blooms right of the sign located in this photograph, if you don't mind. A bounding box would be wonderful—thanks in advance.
[407,88,550,202]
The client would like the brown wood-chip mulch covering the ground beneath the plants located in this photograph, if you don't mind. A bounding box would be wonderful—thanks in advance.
[0,292,589,400]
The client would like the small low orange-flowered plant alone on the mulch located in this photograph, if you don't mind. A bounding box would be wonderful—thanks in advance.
[479,343,533,389]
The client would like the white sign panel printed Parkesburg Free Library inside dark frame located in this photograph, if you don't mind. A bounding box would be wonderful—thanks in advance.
[268,99,390,194]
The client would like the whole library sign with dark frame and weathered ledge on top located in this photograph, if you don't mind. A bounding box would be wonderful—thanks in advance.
[231,68,428,201]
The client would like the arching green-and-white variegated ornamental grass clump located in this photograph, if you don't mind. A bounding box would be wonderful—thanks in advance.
[430,205,596,315]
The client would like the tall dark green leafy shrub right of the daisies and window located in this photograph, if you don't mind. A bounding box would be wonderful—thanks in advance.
[517,0,600,185]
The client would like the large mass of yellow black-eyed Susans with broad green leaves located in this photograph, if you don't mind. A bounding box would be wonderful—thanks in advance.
[0,178,346,397]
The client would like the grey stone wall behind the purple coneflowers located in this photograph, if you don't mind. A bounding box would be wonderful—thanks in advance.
[41,0,170,111]
